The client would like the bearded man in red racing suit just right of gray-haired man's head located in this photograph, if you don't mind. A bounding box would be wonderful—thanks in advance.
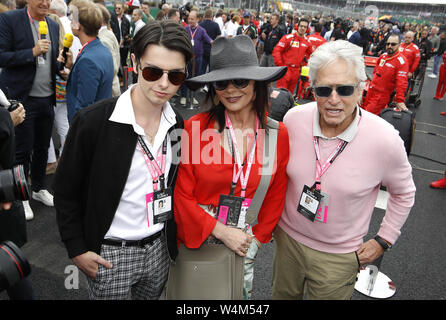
[364,34,410,115]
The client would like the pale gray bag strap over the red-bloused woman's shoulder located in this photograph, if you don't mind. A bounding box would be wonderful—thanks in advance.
[245,117,279,225]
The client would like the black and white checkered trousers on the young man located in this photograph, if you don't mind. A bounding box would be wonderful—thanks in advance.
[87,232,170,300]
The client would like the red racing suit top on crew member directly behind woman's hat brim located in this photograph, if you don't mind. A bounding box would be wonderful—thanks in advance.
[273,33,313,68]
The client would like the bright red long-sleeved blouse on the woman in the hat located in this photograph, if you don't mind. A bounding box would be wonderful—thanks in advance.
[174,113,289,248]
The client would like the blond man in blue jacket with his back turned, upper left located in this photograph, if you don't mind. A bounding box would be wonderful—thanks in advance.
[60,0,114,123]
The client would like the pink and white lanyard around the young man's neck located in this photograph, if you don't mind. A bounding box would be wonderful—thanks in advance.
[138,135,167,191]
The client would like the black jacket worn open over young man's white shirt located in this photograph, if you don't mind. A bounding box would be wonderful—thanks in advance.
[53,97,184,260]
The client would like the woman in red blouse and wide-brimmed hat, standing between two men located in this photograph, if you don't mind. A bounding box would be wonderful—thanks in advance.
[174,35,289,299]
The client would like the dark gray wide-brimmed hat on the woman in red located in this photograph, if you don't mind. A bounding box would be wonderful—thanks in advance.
[186,35,287,89]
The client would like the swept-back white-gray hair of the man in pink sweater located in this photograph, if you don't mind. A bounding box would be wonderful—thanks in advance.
[308,40,367,90]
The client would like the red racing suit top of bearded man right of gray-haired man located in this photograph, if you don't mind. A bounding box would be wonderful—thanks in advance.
[370,52,409,102]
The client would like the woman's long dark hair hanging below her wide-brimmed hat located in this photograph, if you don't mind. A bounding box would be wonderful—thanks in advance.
[205,81,270,133]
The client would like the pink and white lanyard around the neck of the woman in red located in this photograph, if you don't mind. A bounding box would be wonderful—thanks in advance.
[225,112,259,198]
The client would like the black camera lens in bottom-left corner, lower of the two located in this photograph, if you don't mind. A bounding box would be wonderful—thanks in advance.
[0,241,31,292]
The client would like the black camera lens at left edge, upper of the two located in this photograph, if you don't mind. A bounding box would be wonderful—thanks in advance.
[0,165,29,202]
